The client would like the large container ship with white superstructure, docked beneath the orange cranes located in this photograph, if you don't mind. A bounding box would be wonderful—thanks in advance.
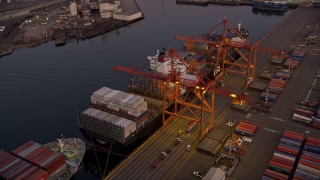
[76,46,212,149]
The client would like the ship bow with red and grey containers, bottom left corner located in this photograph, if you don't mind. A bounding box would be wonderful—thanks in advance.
[0,138,86,180]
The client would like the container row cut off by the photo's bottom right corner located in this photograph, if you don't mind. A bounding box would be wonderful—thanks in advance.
[293,136,320,180]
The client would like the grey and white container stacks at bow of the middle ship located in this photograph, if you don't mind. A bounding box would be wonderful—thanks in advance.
[77,87,149,148]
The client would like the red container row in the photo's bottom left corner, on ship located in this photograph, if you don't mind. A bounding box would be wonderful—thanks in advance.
[0,151,48,180]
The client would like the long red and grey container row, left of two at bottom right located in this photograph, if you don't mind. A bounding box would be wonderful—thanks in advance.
[263,130,304,179]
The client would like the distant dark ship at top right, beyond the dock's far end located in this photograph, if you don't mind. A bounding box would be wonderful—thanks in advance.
[252,1,288,12]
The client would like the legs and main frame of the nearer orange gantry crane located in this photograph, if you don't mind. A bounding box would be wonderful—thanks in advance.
[162,49,245,140]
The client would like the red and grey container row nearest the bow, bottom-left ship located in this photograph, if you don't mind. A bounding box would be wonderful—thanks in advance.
[12,141,67,175]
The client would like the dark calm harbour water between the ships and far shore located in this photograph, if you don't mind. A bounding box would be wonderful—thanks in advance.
[0,0,290,179]
